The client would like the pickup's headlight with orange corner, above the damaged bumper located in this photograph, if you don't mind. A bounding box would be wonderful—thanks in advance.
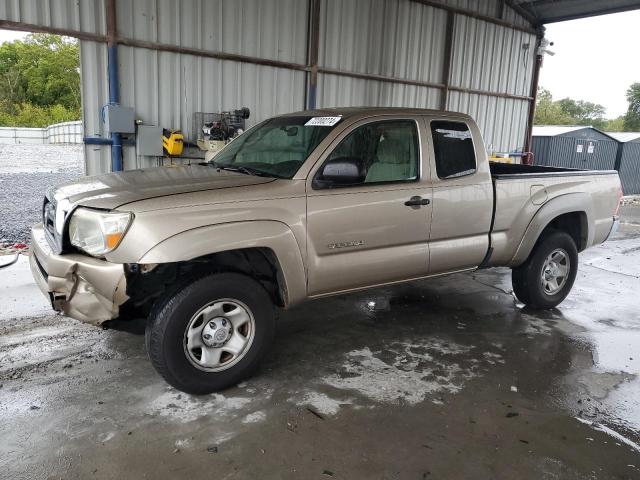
[69,208,133,255]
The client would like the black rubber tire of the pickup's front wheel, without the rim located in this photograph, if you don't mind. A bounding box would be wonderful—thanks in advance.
[145,273,275,394]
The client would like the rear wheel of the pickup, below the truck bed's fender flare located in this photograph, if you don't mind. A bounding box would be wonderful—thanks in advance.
[511,232,578,309]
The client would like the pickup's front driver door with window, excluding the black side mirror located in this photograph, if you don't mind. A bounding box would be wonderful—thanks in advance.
[307,117,432,296]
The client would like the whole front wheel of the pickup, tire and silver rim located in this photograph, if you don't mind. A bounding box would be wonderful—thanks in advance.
[145,273,275,394]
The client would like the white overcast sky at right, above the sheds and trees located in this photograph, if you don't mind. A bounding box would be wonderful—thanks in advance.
[540,11,640,118]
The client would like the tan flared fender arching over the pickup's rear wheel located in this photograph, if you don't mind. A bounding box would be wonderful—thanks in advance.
[509,193,595,266]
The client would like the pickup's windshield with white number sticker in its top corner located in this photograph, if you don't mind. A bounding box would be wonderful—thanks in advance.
[213,116,340,178]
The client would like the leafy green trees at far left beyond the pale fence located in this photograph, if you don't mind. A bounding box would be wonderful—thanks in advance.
[0,33,81,127]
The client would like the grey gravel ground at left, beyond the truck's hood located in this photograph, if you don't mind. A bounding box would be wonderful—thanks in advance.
[0,145,84,247]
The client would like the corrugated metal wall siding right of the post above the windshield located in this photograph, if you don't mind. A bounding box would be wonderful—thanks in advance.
[318,0,536,151]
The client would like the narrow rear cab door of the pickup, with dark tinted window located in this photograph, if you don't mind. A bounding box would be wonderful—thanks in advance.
[425,116,494,274]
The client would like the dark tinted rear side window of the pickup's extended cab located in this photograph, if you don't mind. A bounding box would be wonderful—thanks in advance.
[431,120,476,178]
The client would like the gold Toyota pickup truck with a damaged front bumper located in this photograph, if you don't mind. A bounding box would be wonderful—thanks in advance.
[31,108,622,393]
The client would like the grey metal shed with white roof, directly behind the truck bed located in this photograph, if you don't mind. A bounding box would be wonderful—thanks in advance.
[532,125,618,170]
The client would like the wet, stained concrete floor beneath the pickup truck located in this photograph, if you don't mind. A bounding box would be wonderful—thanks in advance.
[0,218,640,480]
